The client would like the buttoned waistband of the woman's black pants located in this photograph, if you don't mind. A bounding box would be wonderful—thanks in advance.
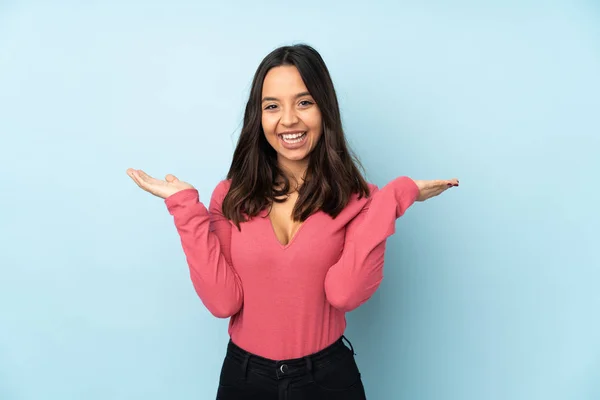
[227,335,355,379]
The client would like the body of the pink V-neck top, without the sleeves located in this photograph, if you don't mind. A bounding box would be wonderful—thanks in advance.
[229,183,367,359]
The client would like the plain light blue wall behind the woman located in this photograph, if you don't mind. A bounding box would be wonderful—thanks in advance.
[0,0,600,400]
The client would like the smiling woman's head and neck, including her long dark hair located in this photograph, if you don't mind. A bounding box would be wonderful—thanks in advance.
[223,45,376,234]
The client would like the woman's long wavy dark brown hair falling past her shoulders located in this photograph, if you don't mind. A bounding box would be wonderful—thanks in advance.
[222,44,370,229]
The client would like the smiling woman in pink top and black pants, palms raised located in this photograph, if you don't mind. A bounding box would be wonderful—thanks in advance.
[127,45,458,400]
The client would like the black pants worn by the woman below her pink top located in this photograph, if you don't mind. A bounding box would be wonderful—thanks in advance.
[217,336,366,400]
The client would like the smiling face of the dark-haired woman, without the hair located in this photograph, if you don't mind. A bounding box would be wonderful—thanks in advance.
[262,65,323,165]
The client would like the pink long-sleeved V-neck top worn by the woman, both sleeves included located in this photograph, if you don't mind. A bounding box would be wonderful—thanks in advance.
[165,177,419,360]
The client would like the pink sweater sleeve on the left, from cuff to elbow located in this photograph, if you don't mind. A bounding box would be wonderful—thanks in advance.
[165,181,244,318]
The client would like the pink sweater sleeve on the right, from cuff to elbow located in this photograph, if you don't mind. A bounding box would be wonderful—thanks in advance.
[325,176,419,312]
